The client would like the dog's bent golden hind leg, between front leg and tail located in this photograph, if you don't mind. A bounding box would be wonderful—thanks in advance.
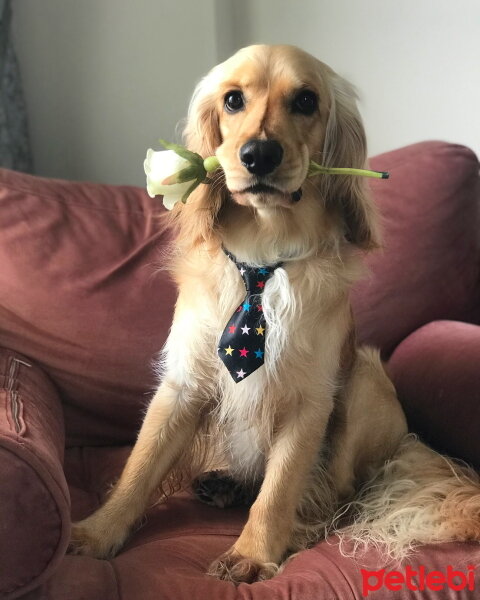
[291,348,407,550]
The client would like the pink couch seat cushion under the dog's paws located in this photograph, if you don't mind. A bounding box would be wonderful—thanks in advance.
[32,448,480,600]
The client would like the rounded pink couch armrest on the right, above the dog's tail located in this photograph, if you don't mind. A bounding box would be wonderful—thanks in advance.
[388,321,480,469]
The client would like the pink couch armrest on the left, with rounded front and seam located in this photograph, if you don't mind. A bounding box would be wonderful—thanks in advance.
[0,349,70,600]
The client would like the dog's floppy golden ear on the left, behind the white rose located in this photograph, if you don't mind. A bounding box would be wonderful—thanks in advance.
[170,71,225,250]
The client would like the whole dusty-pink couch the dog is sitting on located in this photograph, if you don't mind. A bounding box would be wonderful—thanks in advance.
[0,142,480,600]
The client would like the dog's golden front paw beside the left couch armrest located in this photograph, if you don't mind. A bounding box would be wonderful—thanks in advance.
[68,515,126,558]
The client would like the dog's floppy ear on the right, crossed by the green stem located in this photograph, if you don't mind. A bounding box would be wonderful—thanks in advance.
[322,71,380,249]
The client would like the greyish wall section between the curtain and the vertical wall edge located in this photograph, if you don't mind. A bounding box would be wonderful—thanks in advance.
[12,0,217,185]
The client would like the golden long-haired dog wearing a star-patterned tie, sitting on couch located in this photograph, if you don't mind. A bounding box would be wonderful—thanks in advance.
[71,45,480,584]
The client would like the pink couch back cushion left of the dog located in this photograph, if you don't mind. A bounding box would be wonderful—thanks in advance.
[0,169,175,444]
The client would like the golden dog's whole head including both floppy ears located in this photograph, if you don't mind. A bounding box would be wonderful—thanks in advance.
[176,45,377,254]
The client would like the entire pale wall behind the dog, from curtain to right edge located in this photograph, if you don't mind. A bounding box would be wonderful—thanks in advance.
[12,0,480,185]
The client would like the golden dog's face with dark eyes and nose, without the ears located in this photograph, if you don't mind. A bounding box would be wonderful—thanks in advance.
[215,46,330,208]
